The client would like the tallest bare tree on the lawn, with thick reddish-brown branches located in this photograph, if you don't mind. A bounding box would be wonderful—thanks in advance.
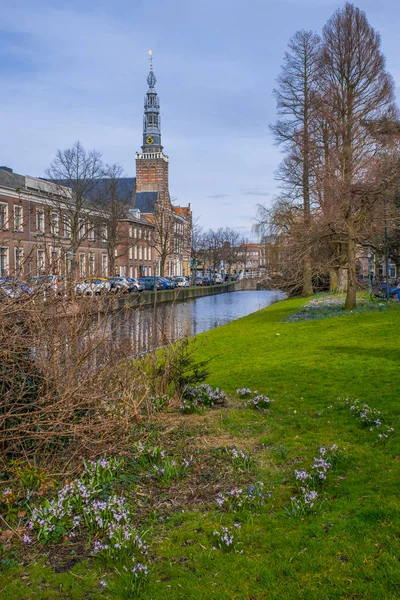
[319,3,396,308]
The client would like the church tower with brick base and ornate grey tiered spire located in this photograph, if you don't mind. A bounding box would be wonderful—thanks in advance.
[135,51,169,198]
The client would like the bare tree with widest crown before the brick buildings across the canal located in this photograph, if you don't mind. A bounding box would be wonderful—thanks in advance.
[46,141,104,279]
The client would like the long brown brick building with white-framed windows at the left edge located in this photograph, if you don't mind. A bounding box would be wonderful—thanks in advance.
[0,167,108,277]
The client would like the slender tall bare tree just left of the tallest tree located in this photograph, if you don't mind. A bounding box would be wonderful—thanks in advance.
[271,31,320,296]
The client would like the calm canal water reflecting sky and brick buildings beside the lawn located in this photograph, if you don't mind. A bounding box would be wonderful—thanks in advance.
[104,290,286,356]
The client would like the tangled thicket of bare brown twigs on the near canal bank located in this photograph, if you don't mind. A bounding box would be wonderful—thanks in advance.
[0,282,204,472]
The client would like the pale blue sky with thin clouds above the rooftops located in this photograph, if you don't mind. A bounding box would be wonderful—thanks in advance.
[0,0,400,236]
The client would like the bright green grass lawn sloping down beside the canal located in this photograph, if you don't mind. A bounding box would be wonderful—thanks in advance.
[0,292,400,600]
